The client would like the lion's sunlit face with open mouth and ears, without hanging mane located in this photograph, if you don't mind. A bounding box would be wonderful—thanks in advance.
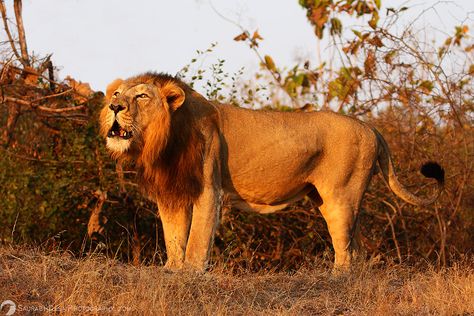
[101,73,185,158]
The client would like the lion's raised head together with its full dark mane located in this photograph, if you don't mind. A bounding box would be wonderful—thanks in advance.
[100,73,204,206]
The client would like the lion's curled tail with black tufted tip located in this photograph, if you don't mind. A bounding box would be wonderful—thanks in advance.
[374,129,444,206]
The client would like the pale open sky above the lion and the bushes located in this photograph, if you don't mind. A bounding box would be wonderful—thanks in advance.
[14,0,474,91]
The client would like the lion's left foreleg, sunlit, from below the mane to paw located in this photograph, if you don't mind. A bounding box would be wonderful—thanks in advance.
[159,207,191,271]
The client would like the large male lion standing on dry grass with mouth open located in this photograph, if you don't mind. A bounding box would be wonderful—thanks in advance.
[100,73,444,270]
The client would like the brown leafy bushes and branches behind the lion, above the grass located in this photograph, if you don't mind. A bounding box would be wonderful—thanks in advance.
[0,1,474,272]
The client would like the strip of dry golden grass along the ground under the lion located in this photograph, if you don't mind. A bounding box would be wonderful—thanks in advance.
[0,246,474,315]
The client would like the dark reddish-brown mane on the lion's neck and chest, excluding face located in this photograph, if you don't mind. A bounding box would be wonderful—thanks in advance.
[134,72,204,209]
